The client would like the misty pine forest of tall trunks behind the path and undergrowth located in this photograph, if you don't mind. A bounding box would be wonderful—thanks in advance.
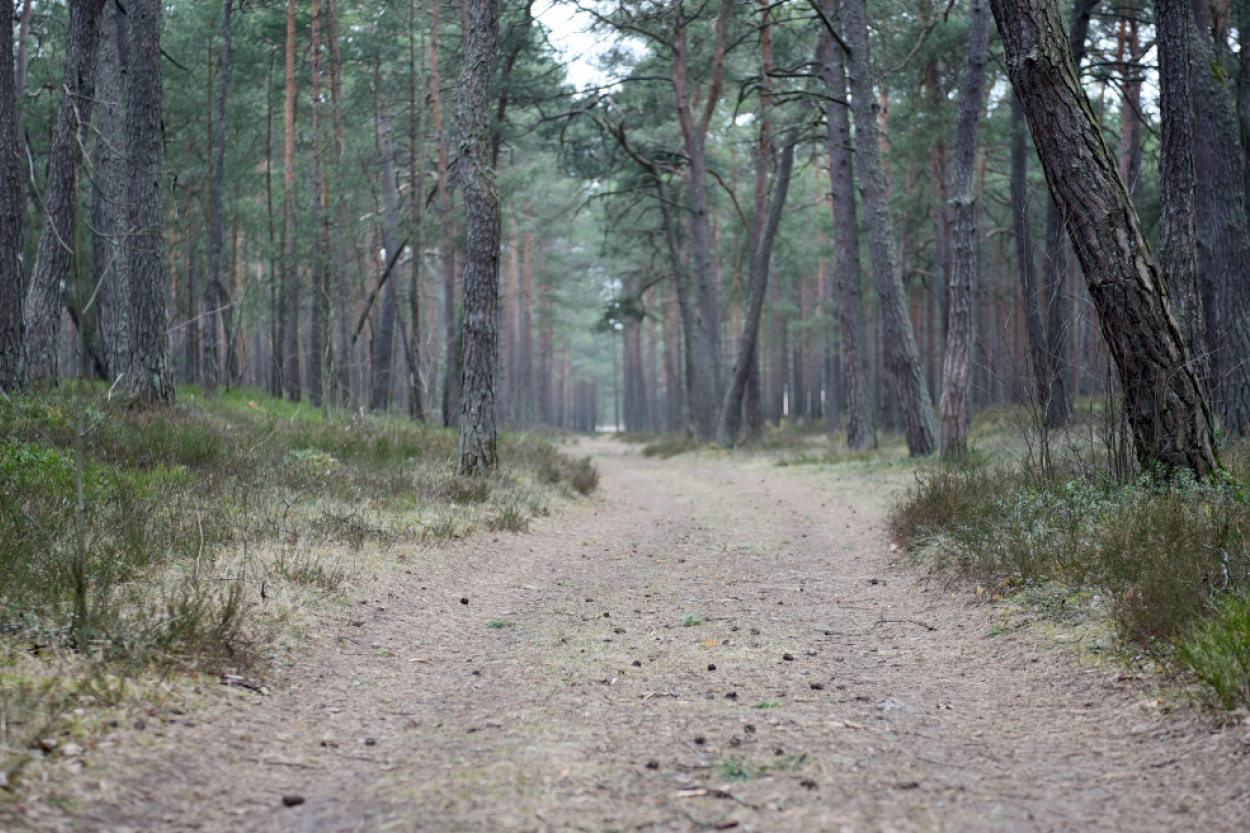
[0,0,1250,473]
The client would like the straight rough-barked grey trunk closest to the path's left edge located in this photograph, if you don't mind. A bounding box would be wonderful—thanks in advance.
[458,0,500,474]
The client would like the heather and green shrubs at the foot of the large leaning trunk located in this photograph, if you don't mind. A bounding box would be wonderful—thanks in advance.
[891,427,1250,708]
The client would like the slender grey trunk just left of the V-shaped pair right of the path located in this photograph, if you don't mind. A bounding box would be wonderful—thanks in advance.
[824,0,873,449]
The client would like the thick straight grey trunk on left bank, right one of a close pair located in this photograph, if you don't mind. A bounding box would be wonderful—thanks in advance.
[126,0,175,404]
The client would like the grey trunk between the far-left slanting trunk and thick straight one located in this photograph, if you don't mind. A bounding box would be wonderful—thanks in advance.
[91,0,130,384]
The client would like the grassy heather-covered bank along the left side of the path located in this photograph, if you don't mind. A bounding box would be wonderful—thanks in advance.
[0,385,599,785]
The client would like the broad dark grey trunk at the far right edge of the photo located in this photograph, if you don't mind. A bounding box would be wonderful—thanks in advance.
[1190,0,1250,437]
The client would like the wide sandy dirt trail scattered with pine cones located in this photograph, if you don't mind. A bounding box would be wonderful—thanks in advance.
[24,440,1250,833]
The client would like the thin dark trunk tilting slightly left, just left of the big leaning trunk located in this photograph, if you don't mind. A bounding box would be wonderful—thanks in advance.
[1011,95,1054,425]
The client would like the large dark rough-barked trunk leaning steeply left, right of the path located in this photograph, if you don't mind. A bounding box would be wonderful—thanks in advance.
[991,0,1219,477]
